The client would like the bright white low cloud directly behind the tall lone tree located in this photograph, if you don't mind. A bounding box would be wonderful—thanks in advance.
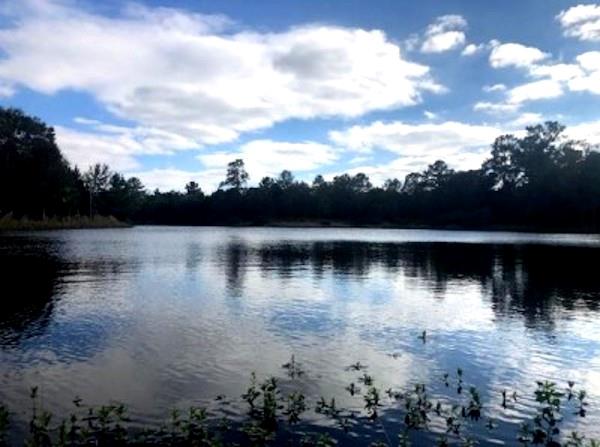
[197,140,339,184]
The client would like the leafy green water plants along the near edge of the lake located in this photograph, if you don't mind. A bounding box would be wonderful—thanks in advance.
[0,356,600,447]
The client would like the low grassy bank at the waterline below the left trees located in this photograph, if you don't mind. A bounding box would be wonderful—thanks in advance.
[0,215,129,231]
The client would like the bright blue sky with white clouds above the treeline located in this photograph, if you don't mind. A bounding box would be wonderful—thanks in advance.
[0,0,600,192]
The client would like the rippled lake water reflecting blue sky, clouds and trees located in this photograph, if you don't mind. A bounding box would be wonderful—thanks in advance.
[0,227,600,443]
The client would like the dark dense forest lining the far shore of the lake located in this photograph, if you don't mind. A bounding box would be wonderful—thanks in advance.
[0,108,600,232]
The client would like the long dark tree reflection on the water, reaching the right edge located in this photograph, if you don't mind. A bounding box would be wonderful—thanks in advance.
[222,241,600,327]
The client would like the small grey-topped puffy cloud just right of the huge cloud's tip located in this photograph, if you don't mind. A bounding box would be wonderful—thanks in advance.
[421,15,467,53]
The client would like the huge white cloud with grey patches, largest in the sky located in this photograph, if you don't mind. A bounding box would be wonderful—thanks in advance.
[0,2,442,157]
